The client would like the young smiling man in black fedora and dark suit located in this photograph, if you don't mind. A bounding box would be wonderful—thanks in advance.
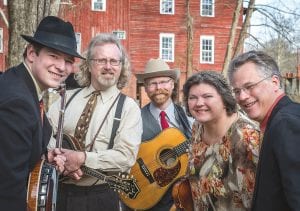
[0,16,82,211]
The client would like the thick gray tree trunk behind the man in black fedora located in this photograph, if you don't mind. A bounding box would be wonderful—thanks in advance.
[7,0,59,67]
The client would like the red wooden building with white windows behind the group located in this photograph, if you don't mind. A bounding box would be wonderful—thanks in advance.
[0,0,242,104]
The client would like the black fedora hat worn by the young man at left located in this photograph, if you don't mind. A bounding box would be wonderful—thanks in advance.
[21,16,84,59]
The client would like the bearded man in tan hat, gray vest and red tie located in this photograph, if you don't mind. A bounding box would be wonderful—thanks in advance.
[129,58,191,211]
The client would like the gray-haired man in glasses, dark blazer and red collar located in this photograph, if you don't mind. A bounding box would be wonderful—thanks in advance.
[228,51,300,211]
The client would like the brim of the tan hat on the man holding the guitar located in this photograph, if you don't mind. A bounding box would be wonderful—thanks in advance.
[135,69,180,83]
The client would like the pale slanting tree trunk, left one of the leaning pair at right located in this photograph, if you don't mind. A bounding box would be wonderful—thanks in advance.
[222,0,243,76]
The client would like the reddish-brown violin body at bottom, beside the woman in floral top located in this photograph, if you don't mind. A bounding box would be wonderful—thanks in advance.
[172,178,194,211]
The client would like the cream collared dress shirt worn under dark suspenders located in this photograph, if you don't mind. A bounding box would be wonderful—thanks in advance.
[48,86,143,186]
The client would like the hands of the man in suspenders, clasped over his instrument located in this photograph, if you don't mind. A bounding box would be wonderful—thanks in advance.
[61,149,86,180]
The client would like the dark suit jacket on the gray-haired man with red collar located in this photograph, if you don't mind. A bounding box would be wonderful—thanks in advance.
[252,96,300,211]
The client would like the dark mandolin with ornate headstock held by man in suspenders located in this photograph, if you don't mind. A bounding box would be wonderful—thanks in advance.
[62,134,140,199]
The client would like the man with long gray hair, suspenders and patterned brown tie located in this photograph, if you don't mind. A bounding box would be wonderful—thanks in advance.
[48,34,142,211]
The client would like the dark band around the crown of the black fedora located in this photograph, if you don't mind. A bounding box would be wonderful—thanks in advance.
[34,31,77,51]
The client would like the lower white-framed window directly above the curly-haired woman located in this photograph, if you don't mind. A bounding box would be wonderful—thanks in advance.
[200,35,215,64]
